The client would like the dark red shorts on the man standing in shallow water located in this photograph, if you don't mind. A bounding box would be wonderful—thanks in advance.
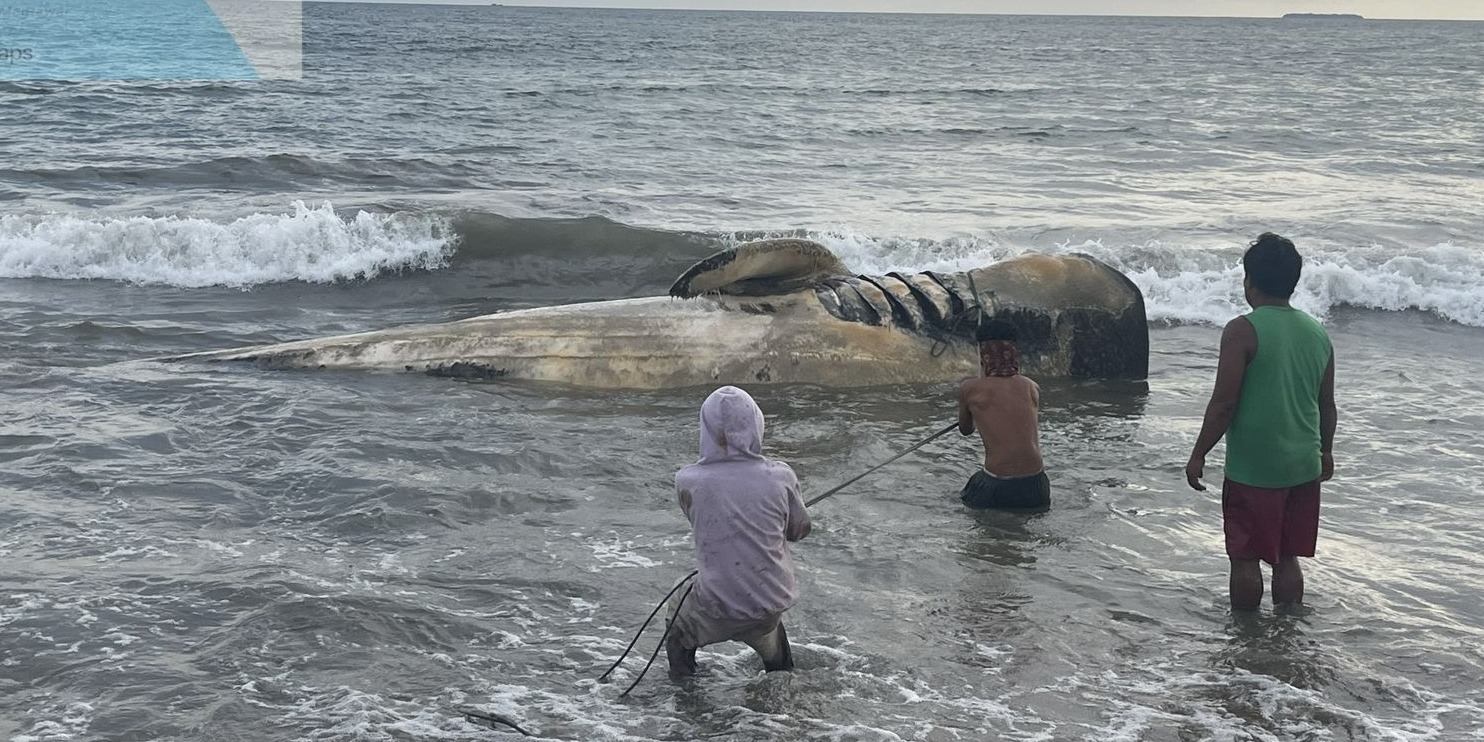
[1221,479,1319,564]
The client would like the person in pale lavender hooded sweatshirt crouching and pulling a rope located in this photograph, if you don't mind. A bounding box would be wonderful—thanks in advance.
[665,386,810,678]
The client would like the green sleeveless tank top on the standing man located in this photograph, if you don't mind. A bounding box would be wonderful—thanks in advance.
[1226,306,1330,487]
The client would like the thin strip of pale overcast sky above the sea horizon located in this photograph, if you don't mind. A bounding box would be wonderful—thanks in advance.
[333,0,1484,21]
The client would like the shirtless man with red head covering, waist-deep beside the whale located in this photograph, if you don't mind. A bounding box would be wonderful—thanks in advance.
[959,319,1051,509]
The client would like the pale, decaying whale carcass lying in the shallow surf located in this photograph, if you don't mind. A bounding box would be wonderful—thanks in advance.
[172,239,1149,389]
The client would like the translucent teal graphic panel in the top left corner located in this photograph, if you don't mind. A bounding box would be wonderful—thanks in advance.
[0,0,283,80]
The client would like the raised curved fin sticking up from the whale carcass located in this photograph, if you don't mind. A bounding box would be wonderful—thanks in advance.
[669,239,849,298]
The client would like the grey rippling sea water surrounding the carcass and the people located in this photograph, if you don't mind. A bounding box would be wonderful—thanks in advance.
[0,4,1484,742]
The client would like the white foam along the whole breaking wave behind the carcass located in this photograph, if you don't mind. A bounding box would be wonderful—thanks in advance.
[0,202,1484,326]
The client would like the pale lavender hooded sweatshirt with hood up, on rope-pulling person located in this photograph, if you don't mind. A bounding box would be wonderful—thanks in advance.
[675,386,810,619]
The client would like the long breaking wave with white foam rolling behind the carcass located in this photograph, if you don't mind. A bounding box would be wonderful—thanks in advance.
[0,203,1484,326]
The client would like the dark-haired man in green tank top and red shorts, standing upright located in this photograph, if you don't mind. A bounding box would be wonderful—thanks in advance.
[1186,233,1336,611]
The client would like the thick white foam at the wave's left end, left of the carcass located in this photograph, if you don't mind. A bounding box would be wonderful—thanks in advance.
[0,202,456,288]
